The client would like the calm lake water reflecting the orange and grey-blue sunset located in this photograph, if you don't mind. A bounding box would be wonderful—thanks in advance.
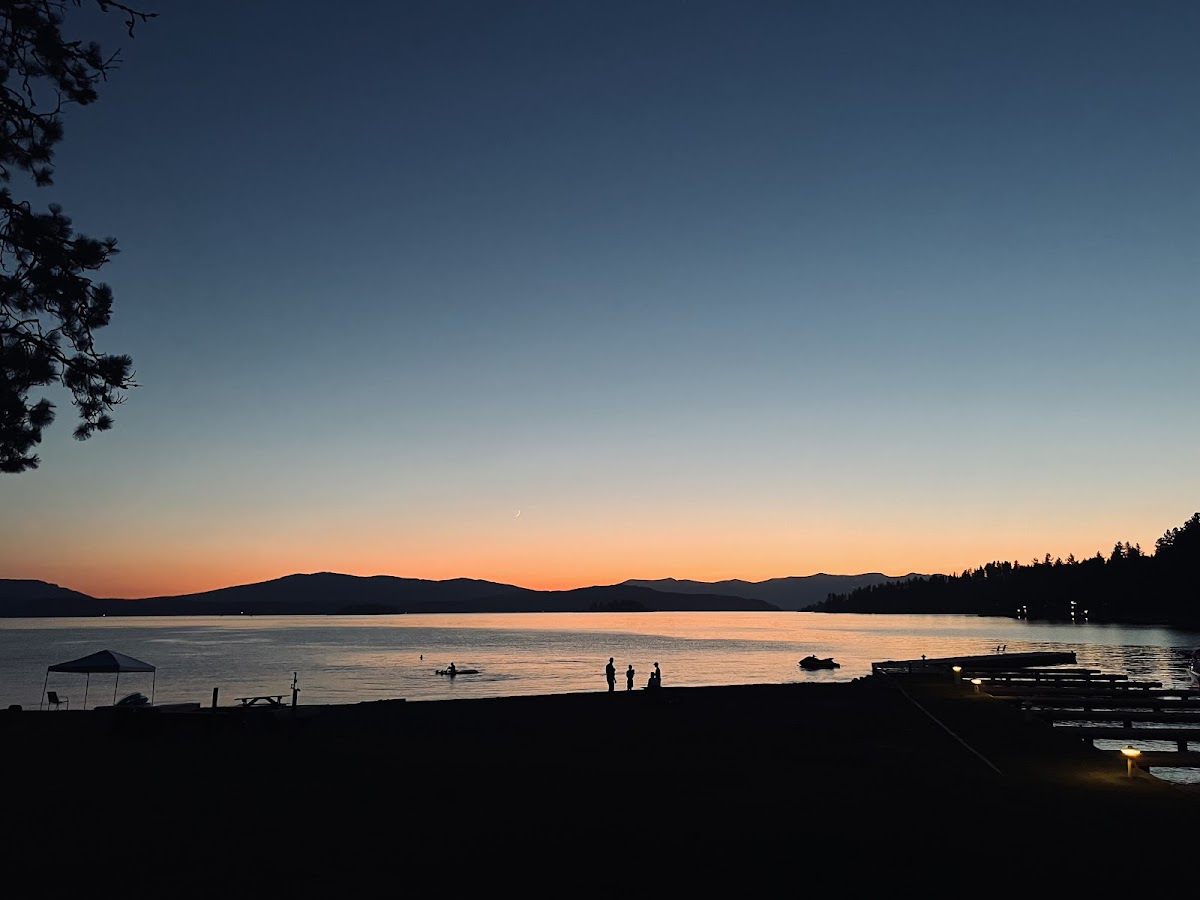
[9,612,1200,782]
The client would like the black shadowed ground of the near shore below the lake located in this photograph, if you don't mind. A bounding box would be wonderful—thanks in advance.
[0,676,1200,900]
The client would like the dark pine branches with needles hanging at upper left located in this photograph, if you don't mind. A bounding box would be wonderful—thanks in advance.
[0,0,156,473]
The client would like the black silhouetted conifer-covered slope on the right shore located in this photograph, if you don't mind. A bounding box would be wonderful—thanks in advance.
[809,512,1200,626]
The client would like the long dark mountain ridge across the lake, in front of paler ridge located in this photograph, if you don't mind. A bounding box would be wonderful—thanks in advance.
[0,572,796,618]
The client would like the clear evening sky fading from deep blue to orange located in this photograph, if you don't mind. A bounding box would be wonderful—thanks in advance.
[0,0,1200,598]
